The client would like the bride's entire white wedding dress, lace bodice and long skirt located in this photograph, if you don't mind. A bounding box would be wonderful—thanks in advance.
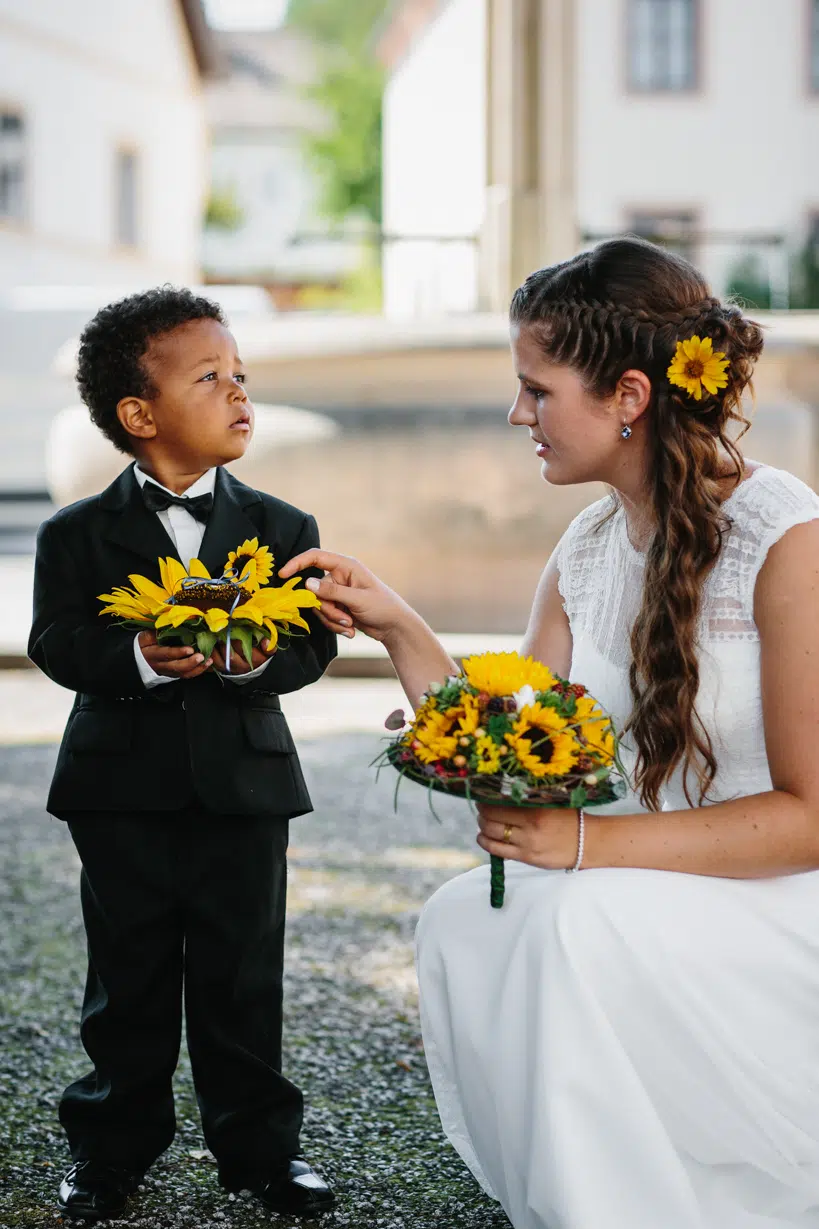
[417,466,819,1229]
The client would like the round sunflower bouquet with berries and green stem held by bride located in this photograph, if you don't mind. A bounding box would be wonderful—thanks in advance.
[379,653,626,908]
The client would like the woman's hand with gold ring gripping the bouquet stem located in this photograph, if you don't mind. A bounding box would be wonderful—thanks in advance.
[477,803,578,870]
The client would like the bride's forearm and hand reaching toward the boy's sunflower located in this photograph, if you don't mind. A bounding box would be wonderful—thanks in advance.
[279,549,457,708]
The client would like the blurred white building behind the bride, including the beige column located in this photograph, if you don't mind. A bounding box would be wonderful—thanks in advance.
[379,0,819,315]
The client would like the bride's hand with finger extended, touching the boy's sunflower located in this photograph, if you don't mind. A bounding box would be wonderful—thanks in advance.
[279,548,412,640]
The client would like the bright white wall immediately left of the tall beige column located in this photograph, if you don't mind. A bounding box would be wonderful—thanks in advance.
[384,0,486,316]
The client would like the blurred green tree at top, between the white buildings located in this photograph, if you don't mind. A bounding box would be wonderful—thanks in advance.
[288,0,386,225]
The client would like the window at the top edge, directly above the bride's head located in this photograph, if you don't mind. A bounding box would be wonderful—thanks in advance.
[628,0,700,91]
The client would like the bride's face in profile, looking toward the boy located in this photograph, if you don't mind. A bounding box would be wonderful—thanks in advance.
[508,324,622,485]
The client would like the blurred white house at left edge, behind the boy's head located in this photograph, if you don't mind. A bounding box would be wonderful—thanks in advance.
[0,0,214,286]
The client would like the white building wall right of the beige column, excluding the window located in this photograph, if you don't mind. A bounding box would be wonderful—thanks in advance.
[576,0,819,299]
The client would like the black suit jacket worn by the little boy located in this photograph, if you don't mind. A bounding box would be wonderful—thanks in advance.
[28,466,336,819]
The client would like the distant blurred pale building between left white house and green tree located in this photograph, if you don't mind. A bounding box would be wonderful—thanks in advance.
[203,26,359,307]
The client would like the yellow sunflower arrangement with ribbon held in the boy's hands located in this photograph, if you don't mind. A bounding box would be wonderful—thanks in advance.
[98,538,321,670]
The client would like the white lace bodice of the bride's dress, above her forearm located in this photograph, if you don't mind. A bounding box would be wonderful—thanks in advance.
[557,462,819,812]
